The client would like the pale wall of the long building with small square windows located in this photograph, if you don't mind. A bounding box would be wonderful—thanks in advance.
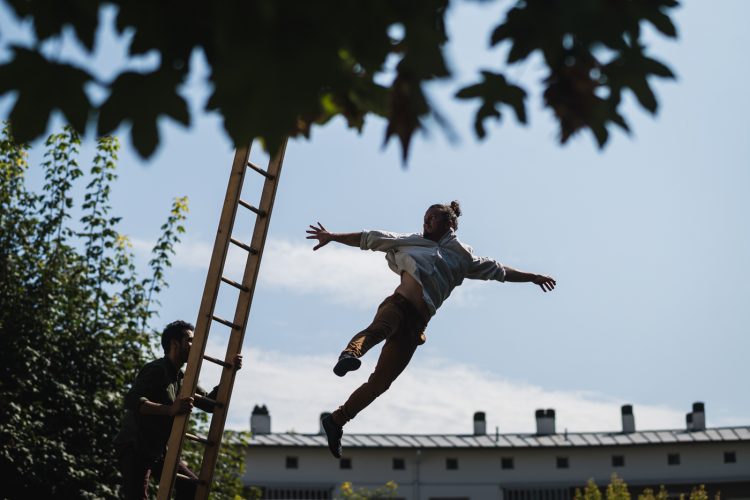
[244,441,750,500]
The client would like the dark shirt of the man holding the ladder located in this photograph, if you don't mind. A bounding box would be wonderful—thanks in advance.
[115,357,218,460]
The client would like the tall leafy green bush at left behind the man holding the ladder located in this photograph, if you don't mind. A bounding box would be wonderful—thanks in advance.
[0,127,187,498]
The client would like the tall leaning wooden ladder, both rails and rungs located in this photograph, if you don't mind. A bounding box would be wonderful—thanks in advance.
[157,141,286,500]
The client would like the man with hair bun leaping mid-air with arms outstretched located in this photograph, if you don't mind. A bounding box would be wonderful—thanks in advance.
[307,201,556,458]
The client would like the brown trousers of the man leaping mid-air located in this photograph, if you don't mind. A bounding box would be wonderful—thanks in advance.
[332,293,428,426]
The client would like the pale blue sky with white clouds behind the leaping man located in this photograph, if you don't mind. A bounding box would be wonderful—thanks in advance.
[0,0,750,432]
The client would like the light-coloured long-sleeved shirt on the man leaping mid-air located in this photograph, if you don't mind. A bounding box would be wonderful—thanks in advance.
[359,229,505,316]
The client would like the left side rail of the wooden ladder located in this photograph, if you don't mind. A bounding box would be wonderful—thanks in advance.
[157,146,250,500]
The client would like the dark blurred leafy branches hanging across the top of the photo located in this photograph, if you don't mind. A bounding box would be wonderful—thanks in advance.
[0,0,677,159]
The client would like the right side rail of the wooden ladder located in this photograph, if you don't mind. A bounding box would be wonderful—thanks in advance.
[195,140,287,500]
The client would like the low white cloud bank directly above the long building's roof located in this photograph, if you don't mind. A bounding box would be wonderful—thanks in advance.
[195,342,704,434]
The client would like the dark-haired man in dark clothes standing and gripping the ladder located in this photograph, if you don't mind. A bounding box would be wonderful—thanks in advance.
[115,321,242,500]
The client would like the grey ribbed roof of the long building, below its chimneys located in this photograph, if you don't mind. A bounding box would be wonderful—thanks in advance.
[249,426,750,448]
